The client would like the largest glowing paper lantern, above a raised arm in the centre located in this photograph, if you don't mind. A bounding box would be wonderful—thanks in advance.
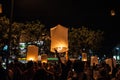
[50,25,68,53]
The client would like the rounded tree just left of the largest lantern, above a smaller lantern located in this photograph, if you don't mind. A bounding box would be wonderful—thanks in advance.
[20,20,50,53]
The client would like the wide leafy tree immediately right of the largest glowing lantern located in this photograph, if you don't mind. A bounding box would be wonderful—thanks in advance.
[69,26,103,55]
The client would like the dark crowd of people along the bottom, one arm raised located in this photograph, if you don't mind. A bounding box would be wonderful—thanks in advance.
[0,51,120,80]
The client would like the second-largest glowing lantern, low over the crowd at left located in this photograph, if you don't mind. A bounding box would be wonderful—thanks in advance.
[26,45,38,61]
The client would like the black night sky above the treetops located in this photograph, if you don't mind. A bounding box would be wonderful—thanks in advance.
[0,0,120,52]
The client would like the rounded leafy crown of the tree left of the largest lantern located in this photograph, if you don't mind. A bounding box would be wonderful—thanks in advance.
[20,20,46,42]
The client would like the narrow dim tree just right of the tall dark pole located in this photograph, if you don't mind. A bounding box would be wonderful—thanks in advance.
[11,22,24,55]
